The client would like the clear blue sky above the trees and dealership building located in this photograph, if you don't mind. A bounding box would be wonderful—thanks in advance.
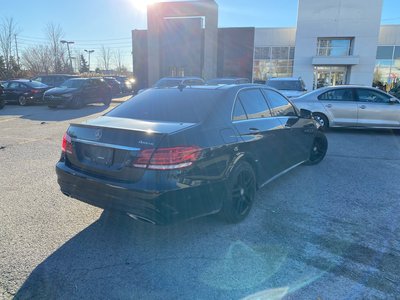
[0,0,400,68]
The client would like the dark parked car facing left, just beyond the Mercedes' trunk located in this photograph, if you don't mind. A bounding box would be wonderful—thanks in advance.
[44,78,112,108]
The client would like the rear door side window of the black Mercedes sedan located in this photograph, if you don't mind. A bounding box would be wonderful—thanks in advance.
[238,89,271,119]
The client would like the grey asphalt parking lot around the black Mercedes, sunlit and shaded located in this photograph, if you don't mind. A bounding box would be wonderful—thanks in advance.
[0,103,400,299]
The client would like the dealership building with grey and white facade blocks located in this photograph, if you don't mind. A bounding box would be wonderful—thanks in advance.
[132,0,400,90]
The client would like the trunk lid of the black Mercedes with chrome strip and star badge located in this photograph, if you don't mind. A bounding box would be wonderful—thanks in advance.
[66,116,194,181]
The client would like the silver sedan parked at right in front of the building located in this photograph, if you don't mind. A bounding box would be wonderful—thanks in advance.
[292,85,400,129]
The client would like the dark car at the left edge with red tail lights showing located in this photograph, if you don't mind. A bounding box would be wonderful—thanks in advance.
[1,79,49,106]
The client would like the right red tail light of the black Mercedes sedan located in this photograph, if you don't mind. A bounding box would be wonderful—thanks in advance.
[133,146,201,170]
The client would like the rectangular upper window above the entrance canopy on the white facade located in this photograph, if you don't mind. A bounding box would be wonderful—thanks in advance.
[317,38,353,56]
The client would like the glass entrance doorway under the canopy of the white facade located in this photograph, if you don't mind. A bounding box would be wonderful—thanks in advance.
[313,66,348,89]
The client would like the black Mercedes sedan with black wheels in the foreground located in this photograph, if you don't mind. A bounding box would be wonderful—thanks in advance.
[56,84,327,224]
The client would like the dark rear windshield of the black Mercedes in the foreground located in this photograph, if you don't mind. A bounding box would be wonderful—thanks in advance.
[106,88,222,123]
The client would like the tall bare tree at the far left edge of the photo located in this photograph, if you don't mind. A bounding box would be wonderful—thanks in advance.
[0,18,17,72]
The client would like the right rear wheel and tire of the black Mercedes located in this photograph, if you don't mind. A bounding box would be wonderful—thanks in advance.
[220,161,256,223]
